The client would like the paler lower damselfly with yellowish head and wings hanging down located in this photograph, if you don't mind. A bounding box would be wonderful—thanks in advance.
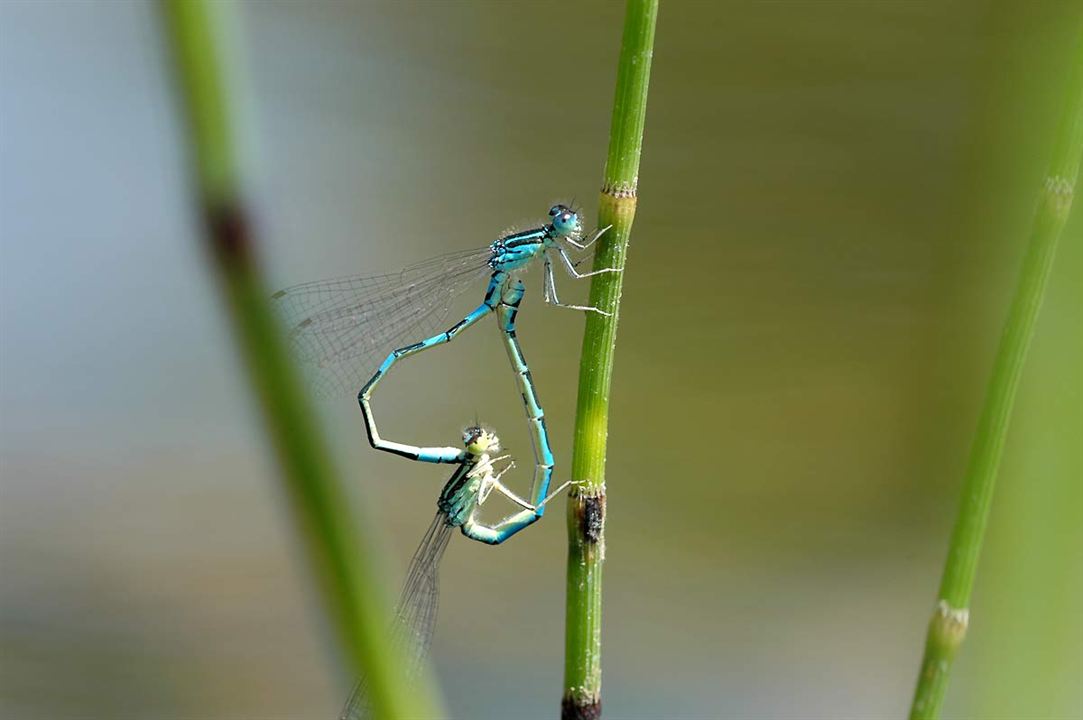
[340,426,571,720]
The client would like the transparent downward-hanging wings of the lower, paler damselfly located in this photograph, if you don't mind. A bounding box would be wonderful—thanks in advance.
[339,512,454,720]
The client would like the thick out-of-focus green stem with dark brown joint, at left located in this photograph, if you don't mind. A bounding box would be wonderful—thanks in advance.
[164,0,433,719]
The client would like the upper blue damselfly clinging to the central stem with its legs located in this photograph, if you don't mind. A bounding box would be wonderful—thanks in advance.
[274,205,619,545]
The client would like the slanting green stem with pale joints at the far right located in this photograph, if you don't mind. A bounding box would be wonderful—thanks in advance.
[910,28,1083,720]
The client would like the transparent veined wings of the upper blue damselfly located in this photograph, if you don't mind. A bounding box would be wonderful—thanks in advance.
[272,247,492,396]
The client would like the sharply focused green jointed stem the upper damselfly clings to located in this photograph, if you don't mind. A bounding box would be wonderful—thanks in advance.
[561,0,658,720]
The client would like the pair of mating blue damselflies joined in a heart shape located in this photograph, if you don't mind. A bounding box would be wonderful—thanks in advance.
[274,205,618,718]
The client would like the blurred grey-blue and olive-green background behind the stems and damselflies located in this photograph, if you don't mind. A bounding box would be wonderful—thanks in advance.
[0,0,1083,719]
